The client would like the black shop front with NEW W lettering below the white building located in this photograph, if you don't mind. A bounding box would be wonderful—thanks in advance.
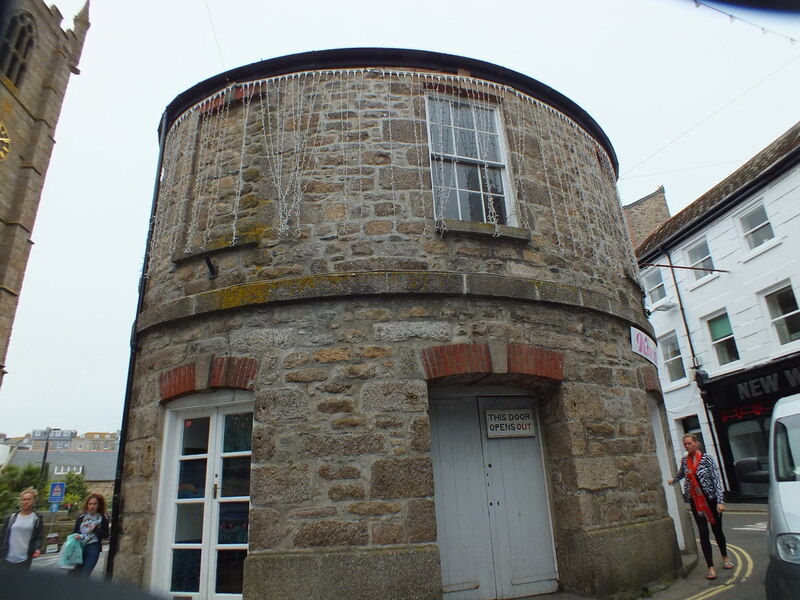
[697,352,800,499]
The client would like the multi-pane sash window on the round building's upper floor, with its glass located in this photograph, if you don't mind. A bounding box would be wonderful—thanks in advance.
[428,98,515,225]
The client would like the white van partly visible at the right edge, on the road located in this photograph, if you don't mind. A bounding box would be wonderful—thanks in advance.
[765,394,800,600]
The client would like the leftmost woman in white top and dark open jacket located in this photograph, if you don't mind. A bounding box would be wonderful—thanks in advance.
[0,487,42,569]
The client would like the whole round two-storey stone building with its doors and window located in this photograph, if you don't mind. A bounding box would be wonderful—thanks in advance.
[113,49,680,600]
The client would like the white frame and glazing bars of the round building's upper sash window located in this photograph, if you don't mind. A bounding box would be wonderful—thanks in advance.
[425,95,519,227]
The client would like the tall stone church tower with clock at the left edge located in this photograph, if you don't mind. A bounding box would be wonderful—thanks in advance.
[0,0,89,384]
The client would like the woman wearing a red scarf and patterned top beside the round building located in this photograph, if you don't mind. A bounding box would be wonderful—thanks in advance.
[667,433,733,579]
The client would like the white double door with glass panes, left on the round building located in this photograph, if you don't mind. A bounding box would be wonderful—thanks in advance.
[154,394,253,600]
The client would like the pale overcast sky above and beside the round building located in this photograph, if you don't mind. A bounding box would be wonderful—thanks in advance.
[0,0,800,435]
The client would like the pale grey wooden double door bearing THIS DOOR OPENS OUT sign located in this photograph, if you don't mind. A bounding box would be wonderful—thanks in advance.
[430,394,558,600]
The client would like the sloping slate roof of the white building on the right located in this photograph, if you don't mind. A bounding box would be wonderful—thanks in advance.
[636,122,800,260]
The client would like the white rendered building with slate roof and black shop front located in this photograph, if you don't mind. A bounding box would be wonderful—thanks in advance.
[636,123,800,496]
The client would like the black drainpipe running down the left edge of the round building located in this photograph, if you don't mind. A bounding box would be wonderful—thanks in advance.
[105,111,167,579]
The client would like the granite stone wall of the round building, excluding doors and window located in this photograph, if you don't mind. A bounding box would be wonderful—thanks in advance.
[115,61,679,600]
